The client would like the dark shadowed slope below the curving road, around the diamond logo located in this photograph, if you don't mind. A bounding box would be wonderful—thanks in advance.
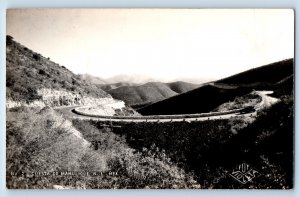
[92,95,294,189]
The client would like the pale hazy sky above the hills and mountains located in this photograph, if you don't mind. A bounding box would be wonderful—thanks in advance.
[7,9,294,80]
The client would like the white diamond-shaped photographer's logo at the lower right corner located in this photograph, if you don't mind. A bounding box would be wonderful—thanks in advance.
[228,163,259,184]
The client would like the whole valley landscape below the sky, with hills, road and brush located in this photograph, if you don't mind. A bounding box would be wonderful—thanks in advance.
[6,36,294,189]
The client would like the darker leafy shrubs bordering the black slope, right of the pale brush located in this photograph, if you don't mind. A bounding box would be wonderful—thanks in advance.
[73,120,199,188]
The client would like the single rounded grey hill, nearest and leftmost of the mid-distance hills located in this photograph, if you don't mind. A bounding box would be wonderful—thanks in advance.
[108,82,177,106]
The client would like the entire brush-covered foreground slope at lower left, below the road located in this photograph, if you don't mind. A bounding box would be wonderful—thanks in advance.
[6,107,200,189]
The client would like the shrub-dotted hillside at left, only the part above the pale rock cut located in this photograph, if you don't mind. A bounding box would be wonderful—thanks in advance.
[6,36,109,101]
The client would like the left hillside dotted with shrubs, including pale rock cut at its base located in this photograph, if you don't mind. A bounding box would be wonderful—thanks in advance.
[6,36,111,106]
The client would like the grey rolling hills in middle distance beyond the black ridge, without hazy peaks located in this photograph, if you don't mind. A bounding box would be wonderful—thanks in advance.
[107,82,199,108]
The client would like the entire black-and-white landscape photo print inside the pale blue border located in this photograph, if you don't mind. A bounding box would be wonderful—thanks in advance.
[6,8,295,190]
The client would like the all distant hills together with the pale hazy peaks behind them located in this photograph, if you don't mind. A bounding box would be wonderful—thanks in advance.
[79,74,200,108]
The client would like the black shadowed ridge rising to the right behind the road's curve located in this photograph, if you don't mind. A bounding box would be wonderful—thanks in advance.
[138,59,293,115]
